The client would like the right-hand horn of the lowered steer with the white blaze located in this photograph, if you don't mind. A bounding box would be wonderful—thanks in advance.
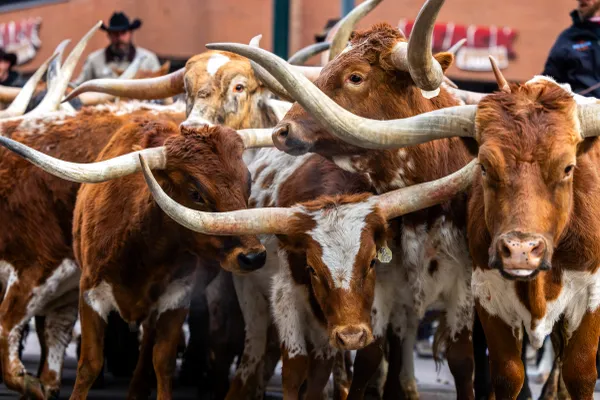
[377,159,478,219]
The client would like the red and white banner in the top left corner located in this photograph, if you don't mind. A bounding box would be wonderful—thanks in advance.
[0,18,42,65]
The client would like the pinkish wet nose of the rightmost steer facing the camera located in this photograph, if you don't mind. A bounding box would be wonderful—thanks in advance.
[498,234,546,276]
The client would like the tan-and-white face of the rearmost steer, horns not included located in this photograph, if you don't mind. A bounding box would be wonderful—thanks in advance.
[184,51,277,129]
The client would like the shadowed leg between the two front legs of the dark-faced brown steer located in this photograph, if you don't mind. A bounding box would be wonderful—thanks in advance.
[127,317,156,400]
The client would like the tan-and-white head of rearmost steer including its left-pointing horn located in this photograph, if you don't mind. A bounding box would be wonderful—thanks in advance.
[67,51,278,129]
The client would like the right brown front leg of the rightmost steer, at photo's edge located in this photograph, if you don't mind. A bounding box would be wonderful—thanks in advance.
[562,308,600,400]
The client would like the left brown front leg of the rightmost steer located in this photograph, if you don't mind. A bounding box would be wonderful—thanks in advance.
[477,302,525,400]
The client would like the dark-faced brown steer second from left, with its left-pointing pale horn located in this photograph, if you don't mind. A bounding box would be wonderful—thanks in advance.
[0,120,276,399]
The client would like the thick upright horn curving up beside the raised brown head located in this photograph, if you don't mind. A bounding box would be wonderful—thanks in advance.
[407,0,444,92]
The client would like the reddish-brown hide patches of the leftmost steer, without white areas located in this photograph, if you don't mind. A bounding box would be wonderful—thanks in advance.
[0,108,181,326]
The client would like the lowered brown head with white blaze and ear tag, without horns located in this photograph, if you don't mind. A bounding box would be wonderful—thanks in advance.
[274,195,387,350]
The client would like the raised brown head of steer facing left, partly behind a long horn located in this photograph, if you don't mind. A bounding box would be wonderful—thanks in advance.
[273,23,457,156]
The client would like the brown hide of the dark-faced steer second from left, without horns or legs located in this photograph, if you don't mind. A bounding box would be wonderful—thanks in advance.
[73,121,264,322]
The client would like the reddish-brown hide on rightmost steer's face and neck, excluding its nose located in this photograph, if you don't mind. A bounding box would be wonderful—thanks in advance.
[468,82,600,308]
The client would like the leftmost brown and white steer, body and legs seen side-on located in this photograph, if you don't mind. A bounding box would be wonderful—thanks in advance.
[0,103,184,399]
